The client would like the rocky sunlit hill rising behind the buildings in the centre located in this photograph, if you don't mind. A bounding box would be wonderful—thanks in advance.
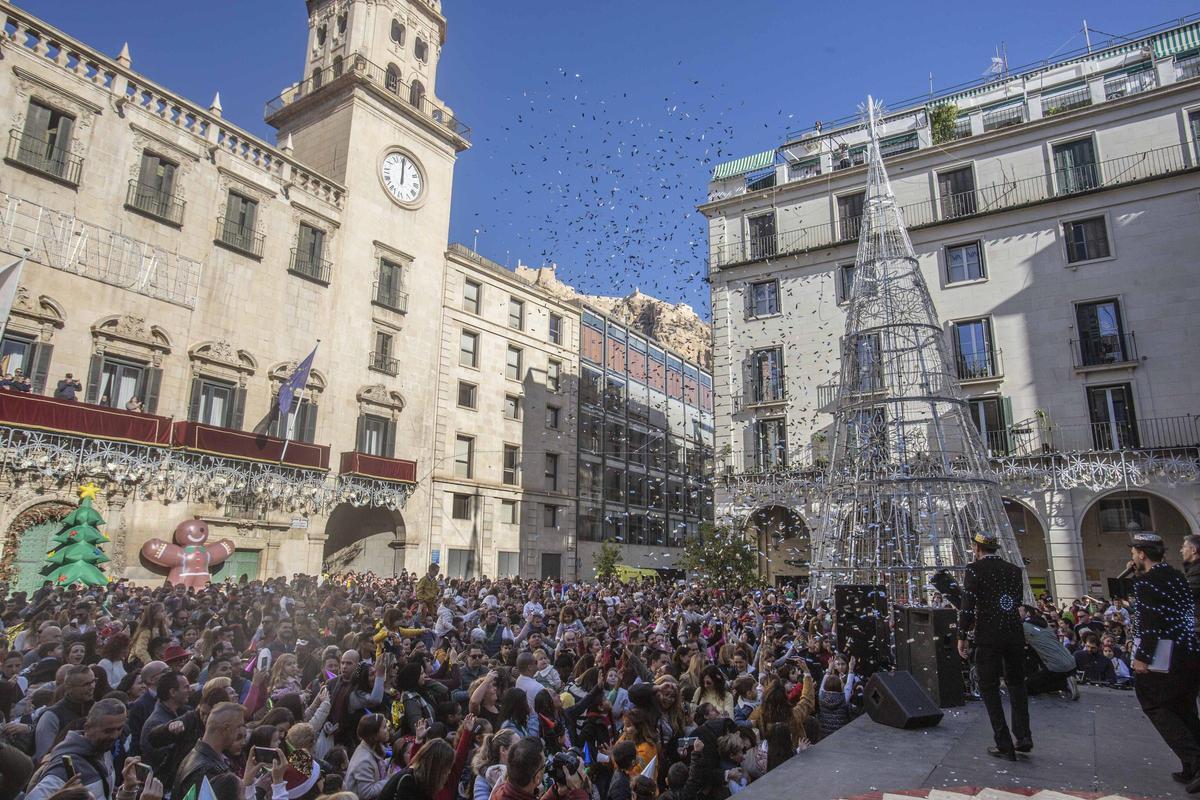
[516,266,713,369]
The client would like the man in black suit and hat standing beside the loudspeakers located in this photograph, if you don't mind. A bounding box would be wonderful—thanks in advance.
[959,533,1033,762]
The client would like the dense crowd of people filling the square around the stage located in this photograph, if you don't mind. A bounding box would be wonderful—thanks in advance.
[0,551,1190,800]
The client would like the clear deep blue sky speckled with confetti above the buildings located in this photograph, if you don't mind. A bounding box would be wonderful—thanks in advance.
[20,0,1196,315]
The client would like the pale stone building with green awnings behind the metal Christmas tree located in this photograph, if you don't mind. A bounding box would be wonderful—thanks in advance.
[701,23,1200,599]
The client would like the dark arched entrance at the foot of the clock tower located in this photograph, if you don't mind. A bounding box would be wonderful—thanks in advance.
[324,503,404,575]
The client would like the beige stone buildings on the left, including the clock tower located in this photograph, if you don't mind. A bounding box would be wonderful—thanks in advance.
[0,0,712,588]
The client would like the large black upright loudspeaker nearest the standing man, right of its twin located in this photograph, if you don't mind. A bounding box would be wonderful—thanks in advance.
[896,607,965,709]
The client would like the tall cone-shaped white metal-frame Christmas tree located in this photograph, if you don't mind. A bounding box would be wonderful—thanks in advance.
[810,98,1028,603]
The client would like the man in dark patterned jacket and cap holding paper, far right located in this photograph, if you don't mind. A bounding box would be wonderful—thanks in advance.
[1129,533,1200,793]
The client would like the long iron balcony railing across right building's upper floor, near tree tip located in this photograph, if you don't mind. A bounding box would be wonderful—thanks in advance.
[709,142,1195,269]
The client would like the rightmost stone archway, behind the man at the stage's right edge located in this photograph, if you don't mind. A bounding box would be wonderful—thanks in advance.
[1079,489,1195,596]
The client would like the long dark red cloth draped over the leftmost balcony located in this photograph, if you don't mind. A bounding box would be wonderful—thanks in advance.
[0,389,170,447]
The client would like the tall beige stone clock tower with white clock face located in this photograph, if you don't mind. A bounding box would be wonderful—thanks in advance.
[266,0,470,570]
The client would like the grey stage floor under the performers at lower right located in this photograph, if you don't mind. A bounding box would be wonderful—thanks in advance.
[738,686,1180,800]
